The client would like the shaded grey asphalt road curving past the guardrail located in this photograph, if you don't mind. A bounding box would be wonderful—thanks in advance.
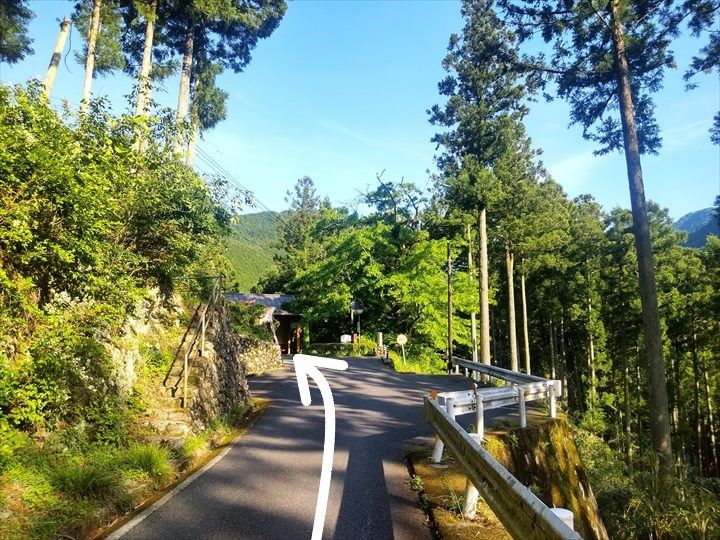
[124,359,486,540]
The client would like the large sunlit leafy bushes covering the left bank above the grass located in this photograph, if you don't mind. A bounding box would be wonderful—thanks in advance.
[0,85,229,443]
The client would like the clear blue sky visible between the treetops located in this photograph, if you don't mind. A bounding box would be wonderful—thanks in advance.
[0,0,720,218]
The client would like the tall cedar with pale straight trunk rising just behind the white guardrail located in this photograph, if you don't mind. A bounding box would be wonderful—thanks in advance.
[428,0,540,369]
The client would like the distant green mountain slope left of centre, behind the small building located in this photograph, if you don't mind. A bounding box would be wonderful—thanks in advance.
[226,211,281,293]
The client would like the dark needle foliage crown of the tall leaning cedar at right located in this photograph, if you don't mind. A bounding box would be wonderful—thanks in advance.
[500,0,680,154]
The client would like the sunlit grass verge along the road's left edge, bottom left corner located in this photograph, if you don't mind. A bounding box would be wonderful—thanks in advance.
[0,403,264,540]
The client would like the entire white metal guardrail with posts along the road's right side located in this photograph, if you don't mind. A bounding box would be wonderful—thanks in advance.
[424,356,580,539]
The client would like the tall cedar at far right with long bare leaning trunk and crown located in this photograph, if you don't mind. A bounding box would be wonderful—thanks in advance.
[499,0,681,478]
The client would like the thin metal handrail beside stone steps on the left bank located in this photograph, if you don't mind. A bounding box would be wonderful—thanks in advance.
[163,276,223,408]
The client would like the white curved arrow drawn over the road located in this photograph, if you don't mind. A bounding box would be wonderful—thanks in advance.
[293,354,347,540]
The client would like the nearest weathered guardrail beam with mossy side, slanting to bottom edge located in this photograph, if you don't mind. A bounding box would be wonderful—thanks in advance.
[424,397,581,540]
